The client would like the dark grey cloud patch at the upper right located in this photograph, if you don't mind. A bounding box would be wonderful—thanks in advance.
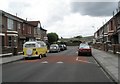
[71,2,117,16]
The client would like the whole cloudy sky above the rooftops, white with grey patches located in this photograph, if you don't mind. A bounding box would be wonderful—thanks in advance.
[0,0,119,38]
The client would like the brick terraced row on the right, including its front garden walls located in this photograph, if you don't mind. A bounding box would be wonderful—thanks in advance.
[94,11,120,53]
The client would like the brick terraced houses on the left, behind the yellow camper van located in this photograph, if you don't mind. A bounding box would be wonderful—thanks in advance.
[0,10,47,55]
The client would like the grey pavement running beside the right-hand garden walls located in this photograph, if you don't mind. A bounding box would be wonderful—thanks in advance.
[92,49,120,84]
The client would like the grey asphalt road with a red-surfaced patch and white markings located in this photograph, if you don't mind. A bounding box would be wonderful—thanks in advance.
[2,47,115,82]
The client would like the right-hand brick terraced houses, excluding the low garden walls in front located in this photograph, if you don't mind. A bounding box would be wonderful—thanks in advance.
[94,11,120,44]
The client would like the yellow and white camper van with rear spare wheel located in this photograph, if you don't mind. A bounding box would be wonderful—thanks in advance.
[23,41,47,59]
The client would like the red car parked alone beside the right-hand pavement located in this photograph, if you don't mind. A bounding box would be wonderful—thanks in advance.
[78,43,92,56]
